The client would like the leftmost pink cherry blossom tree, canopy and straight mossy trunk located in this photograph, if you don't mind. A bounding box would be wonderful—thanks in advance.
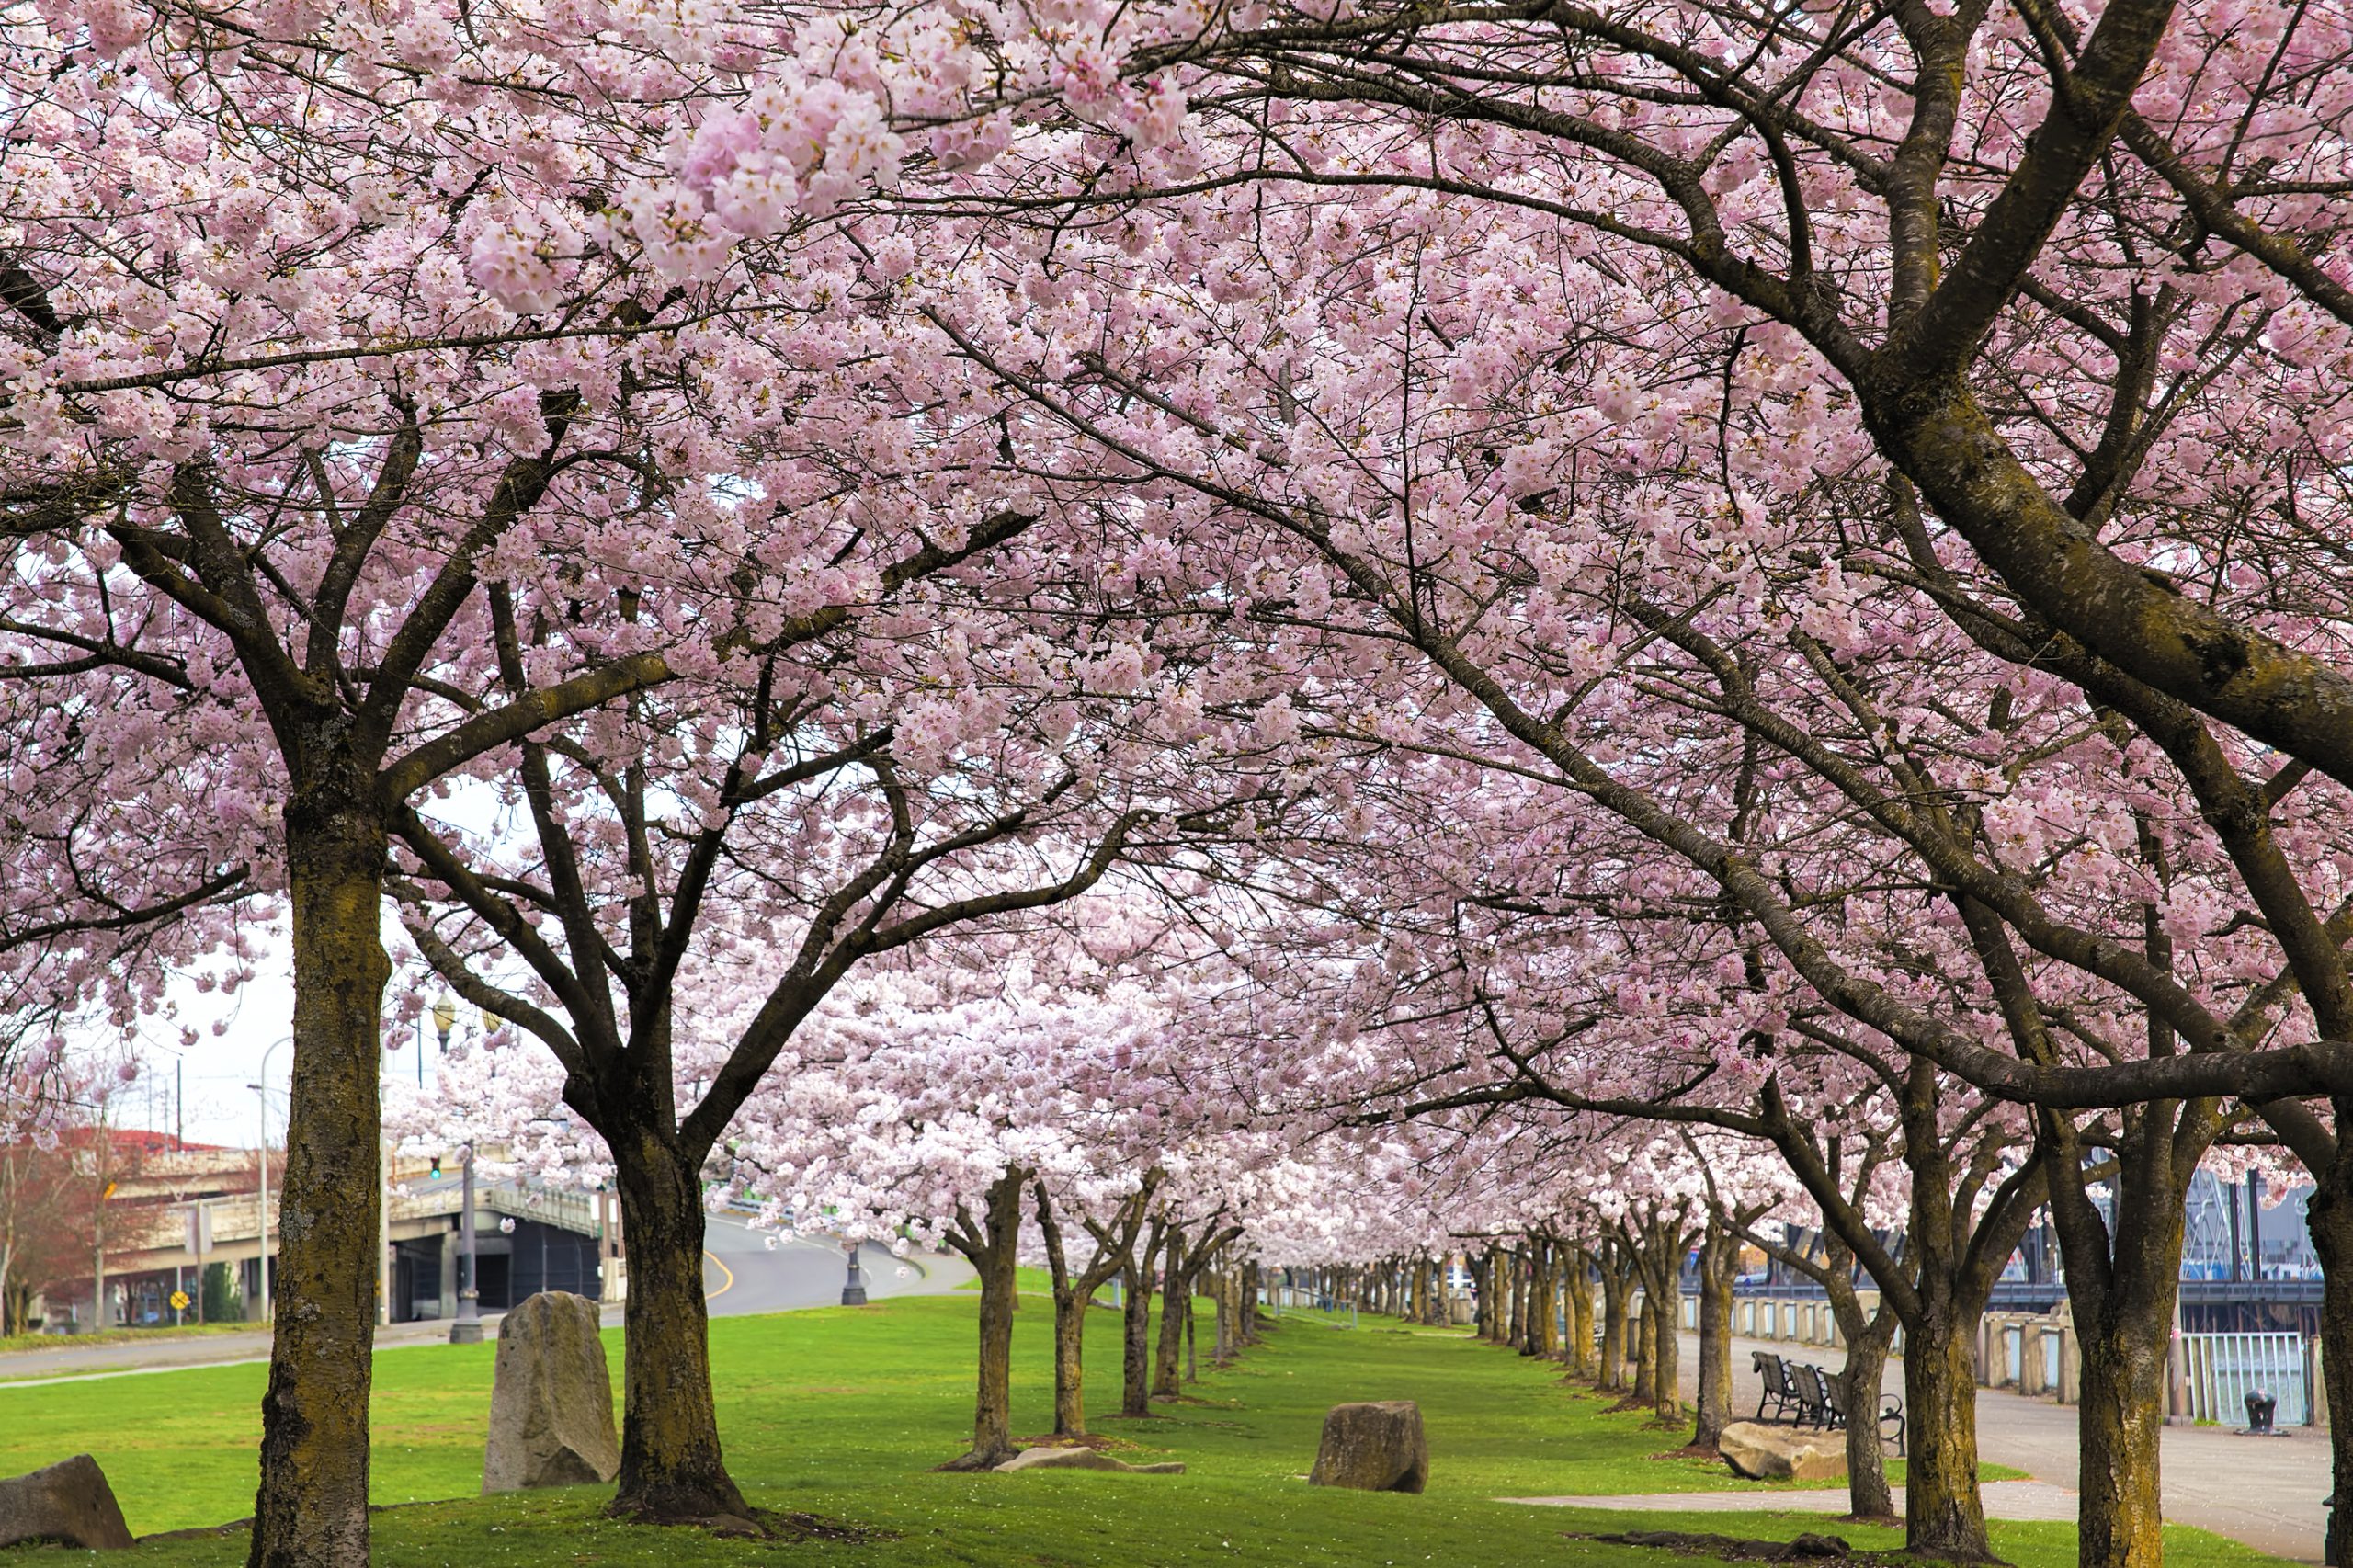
[0,3,973,1568]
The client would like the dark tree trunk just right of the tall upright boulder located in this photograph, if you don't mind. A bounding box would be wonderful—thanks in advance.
[607,1116,751,1523]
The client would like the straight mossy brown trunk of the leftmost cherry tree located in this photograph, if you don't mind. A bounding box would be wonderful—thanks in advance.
[247,805,393,1568]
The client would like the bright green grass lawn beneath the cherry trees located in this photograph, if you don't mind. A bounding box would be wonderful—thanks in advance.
[0,1295,2270,1568]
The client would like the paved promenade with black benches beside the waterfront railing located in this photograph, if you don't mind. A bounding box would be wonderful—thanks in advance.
[1677,1333,2329,1563]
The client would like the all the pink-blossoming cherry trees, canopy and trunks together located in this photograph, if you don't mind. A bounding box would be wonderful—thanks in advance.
[14,0,2353,1568]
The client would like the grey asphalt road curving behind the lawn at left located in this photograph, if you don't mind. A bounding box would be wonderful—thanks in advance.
[0,1215,972,1392]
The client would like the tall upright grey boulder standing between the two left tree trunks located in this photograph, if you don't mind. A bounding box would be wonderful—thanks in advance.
[483,1290,621,1493]
